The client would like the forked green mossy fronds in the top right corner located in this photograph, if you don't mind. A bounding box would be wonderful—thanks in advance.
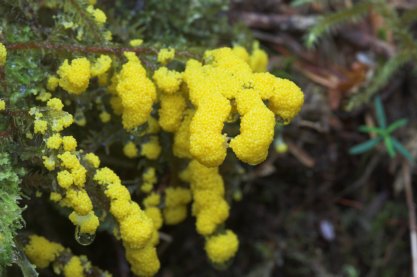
[306,0,417,111]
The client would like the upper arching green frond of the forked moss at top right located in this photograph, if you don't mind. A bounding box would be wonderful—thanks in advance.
[305,1,373,48]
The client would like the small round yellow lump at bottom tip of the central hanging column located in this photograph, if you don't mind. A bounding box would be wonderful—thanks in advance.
[205,230,239,264]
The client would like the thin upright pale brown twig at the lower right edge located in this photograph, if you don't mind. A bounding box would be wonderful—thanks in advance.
[402,160,417,277]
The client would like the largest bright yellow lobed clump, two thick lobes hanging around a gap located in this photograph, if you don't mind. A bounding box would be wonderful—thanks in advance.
[184,46,304,167]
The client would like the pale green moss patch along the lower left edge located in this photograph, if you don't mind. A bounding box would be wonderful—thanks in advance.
[0,152,24,272]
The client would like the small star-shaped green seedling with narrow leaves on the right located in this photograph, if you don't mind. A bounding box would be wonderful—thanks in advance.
[349,97,414,163]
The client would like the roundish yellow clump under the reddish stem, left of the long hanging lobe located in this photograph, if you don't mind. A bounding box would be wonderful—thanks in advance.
[57,58,90,95]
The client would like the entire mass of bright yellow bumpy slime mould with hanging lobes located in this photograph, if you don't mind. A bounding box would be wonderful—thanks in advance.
[23,42,304,276]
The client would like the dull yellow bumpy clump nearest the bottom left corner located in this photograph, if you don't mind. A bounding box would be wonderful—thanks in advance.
[24,235,64,268]
